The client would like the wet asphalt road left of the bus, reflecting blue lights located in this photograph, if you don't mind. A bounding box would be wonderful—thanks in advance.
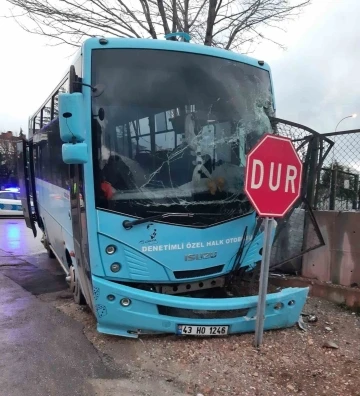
[0,218,188,396]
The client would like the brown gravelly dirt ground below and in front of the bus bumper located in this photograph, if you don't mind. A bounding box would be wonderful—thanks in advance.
[43,293,360,396]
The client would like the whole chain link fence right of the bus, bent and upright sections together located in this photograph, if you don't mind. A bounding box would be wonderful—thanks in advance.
[235,122,360,278]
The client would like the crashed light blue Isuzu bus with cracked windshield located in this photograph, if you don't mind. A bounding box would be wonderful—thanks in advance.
[18,34,308,337]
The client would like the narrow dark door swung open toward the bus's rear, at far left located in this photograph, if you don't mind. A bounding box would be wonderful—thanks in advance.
[16,139,37,237]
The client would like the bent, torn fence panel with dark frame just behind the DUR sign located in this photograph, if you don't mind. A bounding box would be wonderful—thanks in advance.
[238,118,333,273]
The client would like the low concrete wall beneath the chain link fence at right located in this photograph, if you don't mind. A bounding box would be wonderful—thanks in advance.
[302,211,360,287]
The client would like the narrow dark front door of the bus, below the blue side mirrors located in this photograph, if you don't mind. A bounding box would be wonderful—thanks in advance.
[70,165,94,311]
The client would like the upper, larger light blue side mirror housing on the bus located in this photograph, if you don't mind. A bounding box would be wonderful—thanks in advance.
[59,92,85,143]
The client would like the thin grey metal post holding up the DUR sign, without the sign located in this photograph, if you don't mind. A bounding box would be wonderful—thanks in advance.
[254,217,274,347]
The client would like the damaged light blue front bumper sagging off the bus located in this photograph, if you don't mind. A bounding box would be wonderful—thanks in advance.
[93,276,309,338]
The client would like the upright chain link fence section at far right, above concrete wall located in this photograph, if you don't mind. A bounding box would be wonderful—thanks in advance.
[314,130,360,211]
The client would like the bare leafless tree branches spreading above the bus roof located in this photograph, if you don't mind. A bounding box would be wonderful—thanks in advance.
[6,0,311,52]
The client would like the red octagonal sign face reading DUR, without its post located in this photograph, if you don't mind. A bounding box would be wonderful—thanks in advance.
[245,134,303,217]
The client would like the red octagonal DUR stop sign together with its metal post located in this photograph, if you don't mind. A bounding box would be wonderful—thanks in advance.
[245,134,303,347]
